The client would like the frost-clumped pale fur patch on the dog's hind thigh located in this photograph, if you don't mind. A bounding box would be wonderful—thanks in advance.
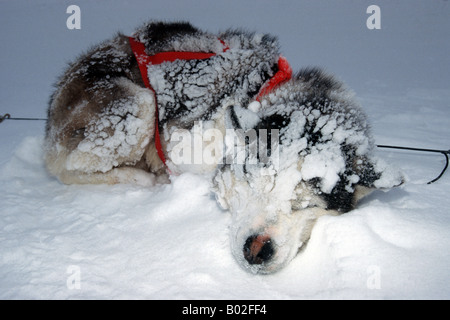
[66,82,154,173]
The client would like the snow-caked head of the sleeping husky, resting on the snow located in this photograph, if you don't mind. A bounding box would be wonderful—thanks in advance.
[215,70,402,274]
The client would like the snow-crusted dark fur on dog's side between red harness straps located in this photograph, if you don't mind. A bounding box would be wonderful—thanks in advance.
[148,31,278,124]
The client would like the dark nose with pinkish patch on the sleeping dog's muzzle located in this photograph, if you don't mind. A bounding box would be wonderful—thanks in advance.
[244,234,274,264]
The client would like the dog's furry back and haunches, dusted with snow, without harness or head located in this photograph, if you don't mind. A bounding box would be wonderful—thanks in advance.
[46,22,279,183]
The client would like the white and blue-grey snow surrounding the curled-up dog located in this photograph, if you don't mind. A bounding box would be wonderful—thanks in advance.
[0,0,450,299]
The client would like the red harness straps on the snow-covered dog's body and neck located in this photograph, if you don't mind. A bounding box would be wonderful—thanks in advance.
[129,37,292,168]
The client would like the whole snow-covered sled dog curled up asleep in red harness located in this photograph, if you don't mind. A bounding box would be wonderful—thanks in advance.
[45,22,402,273]
